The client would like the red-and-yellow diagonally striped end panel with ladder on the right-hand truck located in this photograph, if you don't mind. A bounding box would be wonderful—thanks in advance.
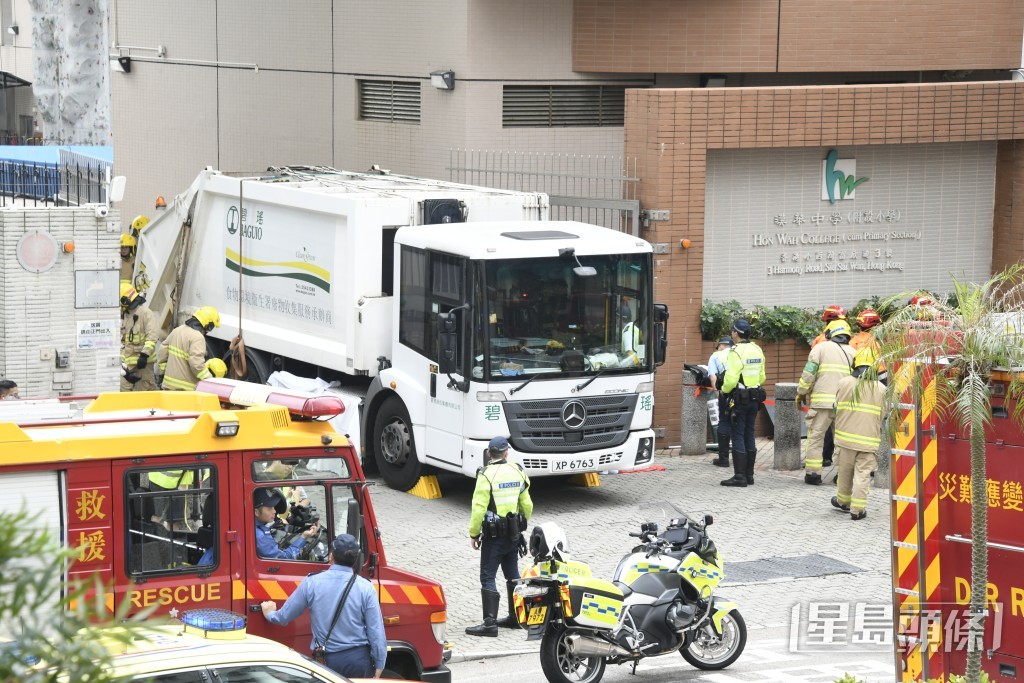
[889,362,943,681]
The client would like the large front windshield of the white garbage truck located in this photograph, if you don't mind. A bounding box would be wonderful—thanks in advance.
[472,254,651,382]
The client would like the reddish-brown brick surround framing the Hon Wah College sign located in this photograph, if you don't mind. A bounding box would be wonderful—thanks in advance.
[626,82,1024,444]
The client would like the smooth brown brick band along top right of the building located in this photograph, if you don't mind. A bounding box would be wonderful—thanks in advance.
[572,0,1024,74]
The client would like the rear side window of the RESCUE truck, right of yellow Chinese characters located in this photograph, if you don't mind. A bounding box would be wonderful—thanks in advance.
[125,466,219,577]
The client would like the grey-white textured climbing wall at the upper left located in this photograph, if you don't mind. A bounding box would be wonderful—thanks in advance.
[30,0,111,144]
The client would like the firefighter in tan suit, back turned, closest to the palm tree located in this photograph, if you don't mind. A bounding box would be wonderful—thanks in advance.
[831,346,886,519]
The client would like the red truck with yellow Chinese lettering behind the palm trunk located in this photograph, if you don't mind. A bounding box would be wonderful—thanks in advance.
[891,373,1024,681]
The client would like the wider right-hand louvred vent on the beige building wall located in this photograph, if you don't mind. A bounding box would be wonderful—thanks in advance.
[502,85,626,128]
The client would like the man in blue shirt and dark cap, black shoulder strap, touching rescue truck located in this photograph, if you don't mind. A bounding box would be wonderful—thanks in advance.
[261,533,387,678]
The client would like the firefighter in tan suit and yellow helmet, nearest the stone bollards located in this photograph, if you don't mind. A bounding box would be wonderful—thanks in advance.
[797,321,854,485]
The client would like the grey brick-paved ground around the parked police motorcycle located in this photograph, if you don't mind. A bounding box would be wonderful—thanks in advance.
[373,442,891,680]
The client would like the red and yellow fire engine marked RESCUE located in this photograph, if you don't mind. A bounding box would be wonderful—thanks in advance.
[0,380,451,682]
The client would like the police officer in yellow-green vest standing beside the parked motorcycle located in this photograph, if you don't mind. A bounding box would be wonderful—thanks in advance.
[466,436,534,637]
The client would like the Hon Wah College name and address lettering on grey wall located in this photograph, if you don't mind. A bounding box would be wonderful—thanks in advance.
[751,209,924,275]
